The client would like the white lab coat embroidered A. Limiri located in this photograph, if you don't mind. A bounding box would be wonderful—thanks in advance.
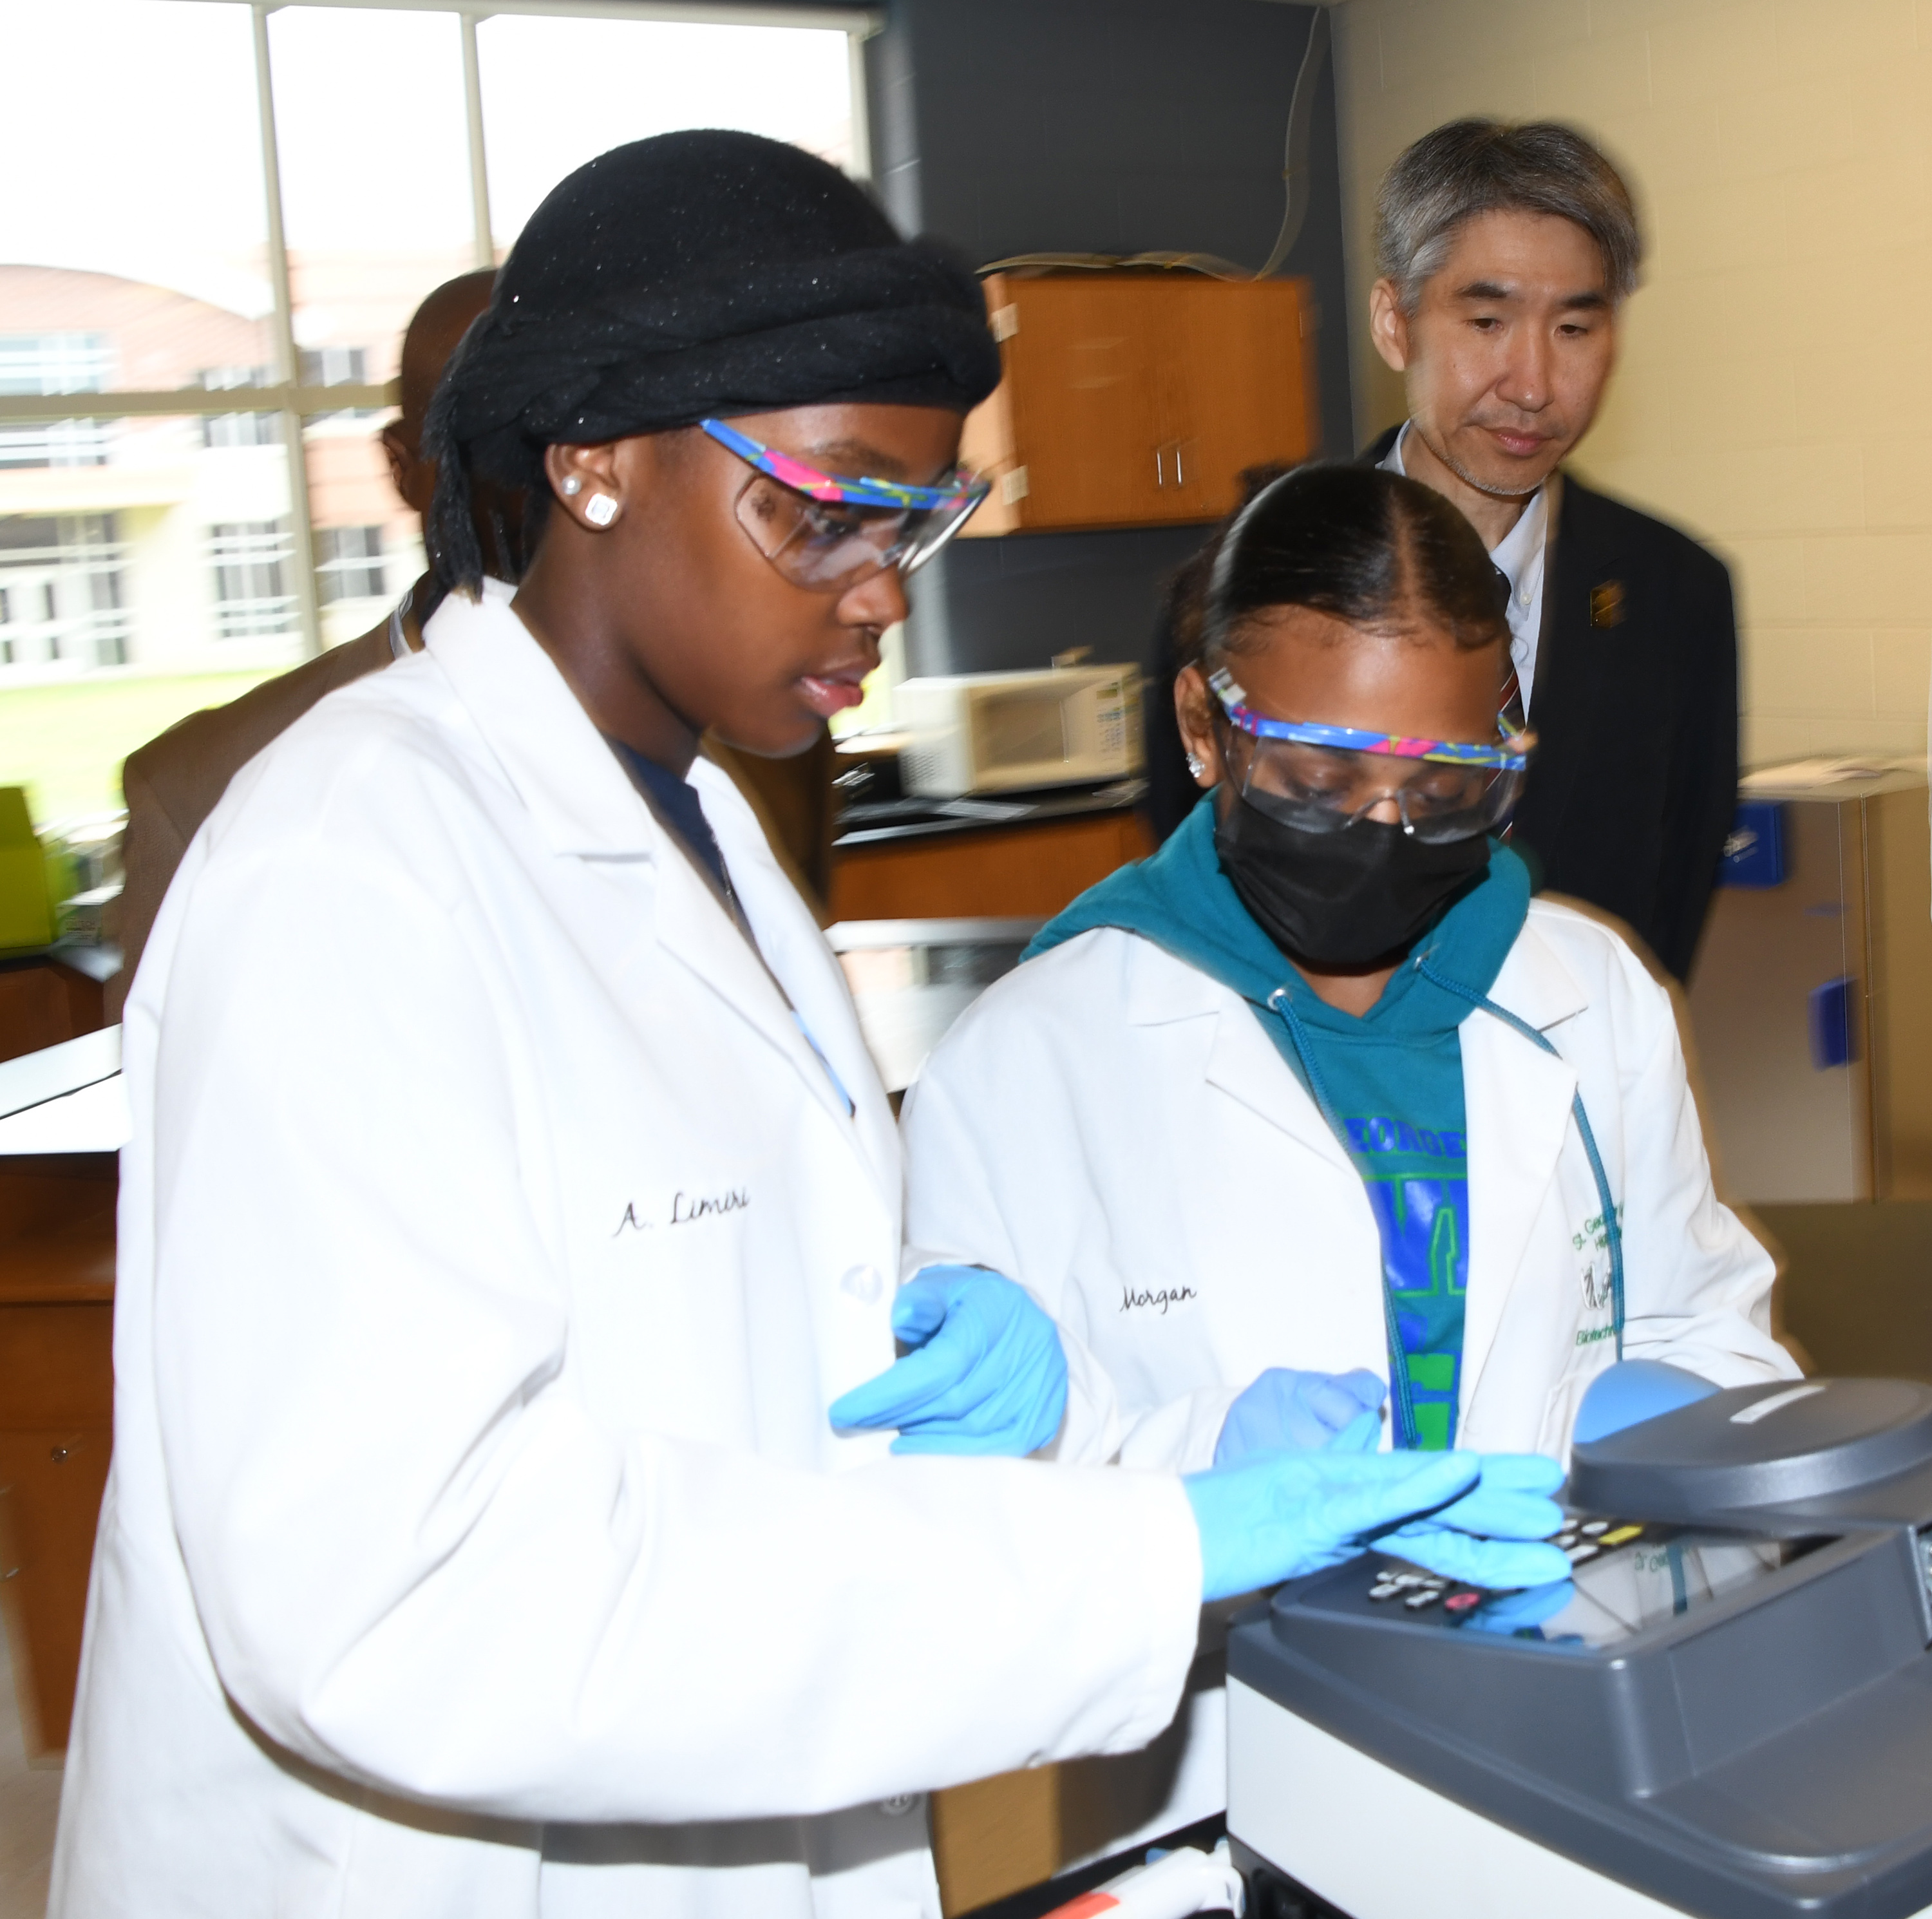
[52,587,1200,1919]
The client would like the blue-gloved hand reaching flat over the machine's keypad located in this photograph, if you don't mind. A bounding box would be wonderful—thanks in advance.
[1182,1451,1569,1600]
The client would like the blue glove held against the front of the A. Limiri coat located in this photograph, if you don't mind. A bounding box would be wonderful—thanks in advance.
[831,1266,1066,1457]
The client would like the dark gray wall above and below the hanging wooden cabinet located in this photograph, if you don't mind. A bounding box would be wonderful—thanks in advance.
[867,0,1352,672]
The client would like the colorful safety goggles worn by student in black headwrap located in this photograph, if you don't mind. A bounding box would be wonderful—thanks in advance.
[697,419,991,593]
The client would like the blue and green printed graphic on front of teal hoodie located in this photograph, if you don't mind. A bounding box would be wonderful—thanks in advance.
[1343,1113,1468,1451]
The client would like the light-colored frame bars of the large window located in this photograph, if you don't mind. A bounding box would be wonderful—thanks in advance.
[0,0,885,659]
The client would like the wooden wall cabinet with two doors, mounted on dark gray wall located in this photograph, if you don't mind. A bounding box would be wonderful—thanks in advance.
[962,272,1320,537]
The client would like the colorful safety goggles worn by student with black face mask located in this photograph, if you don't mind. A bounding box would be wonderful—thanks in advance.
[1208,666,1536,840]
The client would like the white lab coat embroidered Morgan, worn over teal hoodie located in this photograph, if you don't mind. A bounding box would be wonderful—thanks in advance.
[904,900,1797,1849]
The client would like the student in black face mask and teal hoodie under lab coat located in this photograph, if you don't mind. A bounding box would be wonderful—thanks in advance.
[904,466,1795,1849]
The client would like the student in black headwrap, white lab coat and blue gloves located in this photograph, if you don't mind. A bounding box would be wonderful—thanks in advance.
[52,133,1561,1919]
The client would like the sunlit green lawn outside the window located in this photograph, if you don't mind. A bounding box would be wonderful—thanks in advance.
[0,666,284,825]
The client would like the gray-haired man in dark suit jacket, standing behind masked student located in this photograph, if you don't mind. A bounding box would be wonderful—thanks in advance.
[1153,120,1737,980]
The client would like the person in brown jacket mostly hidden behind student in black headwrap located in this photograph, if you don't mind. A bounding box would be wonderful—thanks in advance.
[108,269,502,1021]
